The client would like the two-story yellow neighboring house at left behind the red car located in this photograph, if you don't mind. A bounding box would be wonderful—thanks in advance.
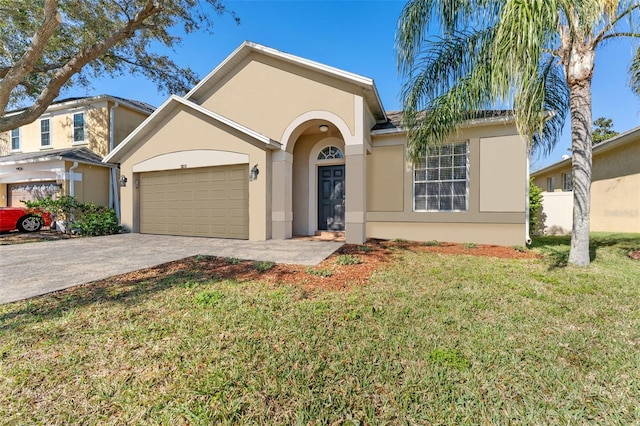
[0,95,154,207]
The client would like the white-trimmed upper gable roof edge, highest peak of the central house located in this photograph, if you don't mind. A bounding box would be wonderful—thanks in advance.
[185,41,387,123]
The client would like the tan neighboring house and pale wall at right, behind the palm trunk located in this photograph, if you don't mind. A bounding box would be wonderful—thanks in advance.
[531,127,640,234]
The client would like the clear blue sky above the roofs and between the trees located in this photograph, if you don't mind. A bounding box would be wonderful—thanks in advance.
[65,0,640,170]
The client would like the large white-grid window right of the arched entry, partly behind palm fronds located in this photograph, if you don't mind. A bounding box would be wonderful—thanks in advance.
[413,141,469,212]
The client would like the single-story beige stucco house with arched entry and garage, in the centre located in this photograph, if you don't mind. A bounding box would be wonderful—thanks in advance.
[104,42,528,245]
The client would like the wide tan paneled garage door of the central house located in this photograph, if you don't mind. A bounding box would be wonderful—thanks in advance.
[140,164,249,239]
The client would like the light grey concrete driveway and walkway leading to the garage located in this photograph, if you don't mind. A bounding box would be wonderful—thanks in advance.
[0,233,342,304]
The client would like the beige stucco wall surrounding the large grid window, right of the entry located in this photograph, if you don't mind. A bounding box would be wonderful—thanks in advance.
[366,124,526,245]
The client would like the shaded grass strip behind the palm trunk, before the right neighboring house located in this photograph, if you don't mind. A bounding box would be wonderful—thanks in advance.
[529,232,640,269]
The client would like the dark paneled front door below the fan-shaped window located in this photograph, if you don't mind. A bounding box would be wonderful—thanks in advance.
[318,165,345,231]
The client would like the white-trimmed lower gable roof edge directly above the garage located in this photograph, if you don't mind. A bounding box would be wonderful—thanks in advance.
[102,95,281,163]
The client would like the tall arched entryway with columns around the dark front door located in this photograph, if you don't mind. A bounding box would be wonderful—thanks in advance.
[272,112,365,242]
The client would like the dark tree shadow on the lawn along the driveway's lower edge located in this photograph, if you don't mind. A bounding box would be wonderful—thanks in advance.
[0,256,222,330]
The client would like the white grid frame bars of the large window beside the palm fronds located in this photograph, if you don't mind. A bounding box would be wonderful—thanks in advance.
[411,140,471,213]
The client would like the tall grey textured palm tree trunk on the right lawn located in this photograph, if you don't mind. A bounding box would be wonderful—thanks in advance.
[569,78,592,266]
